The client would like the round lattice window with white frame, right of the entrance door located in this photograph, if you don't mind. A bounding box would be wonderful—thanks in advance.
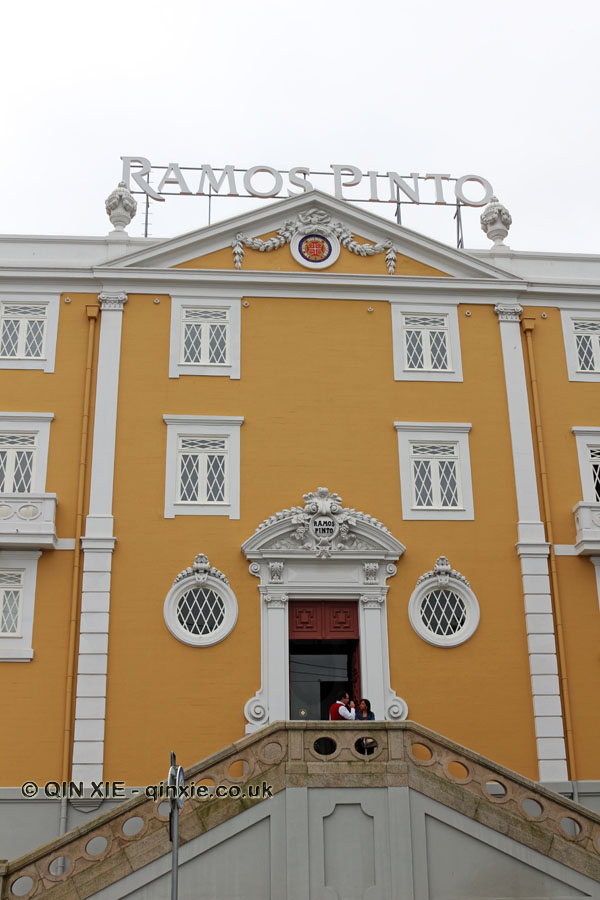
[408,578,479,647]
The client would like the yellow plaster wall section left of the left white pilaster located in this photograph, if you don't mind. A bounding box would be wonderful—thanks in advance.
[0,294,97,786]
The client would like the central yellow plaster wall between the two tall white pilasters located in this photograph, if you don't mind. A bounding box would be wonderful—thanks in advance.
[99,296,537,783]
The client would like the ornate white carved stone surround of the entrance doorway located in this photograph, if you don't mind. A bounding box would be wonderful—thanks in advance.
[242,487,408,733]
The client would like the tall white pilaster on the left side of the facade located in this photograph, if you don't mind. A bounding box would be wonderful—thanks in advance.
[72,292,127,784]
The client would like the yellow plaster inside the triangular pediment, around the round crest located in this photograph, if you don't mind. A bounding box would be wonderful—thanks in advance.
[174,231,448,278]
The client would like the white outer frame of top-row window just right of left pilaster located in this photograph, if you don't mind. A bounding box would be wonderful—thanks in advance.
[169,294,242,379]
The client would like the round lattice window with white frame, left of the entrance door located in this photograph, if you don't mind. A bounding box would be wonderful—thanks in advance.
[163,575,237,647]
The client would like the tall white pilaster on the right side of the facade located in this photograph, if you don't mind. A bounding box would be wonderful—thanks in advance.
[495,303,568,781]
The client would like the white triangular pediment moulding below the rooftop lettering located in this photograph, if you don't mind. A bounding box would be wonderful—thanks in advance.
[105,190,515,281]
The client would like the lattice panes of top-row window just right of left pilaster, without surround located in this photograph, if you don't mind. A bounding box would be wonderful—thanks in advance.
[181,306,230,366]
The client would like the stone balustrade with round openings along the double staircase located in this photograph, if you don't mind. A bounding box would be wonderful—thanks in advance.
[0,722,600,900]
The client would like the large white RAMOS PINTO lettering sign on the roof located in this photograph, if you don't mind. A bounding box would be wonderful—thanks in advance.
[121,156,494,206]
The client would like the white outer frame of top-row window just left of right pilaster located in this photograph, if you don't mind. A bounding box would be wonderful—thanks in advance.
[390,296,463,381]
